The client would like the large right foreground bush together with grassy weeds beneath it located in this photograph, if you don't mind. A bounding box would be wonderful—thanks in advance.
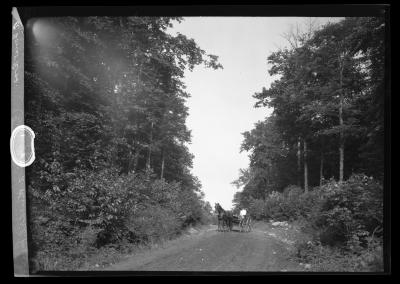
[297,174,383,272]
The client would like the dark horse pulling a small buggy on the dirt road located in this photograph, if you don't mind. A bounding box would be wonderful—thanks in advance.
[215,203,251,232]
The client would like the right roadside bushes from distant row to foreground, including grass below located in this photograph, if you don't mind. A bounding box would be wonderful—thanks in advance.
[241,174,383,271]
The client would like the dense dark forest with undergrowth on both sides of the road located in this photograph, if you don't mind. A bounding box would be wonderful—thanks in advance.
[20,17,388,271]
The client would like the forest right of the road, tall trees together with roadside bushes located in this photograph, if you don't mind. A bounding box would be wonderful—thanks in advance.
[233,17,387,270]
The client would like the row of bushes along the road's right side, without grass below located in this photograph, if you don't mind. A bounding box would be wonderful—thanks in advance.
[260,174,383,251]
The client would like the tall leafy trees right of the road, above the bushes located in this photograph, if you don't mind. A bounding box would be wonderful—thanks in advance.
[234,17,385,203]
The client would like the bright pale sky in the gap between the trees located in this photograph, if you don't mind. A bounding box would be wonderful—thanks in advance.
[167,17,340,209]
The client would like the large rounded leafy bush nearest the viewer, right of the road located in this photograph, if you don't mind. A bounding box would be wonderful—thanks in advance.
[315,174,383,249]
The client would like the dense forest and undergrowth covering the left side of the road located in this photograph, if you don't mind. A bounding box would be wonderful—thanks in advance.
[25,17,222,270]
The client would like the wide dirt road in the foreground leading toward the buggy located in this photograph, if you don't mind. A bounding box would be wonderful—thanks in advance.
[108,226,302,271]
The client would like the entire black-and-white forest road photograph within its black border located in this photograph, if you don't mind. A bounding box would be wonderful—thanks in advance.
[10,5,391,276]
